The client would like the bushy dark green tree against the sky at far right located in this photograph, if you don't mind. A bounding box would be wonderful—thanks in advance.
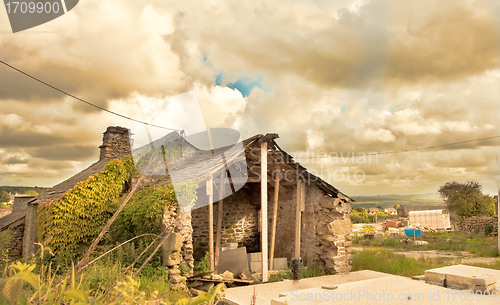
[438,180,492,216]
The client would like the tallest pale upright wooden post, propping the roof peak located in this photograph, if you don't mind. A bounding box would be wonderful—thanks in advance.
[260,141,269,282]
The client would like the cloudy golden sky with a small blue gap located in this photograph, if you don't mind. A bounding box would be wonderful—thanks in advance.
[0,0,500,196]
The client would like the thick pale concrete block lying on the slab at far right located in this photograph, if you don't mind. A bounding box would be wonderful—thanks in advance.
[425,265,500,291]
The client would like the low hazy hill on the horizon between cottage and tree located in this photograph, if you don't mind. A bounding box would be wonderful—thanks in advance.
[351,193,443,208]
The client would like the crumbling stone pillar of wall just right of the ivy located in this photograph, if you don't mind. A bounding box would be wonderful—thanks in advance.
[162,205,194,286]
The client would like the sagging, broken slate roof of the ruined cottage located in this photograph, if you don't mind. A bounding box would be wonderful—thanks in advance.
[0,132,354,230]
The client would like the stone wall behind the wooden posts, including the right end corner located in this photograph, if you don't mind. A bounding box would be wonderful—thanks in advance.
[192,180,352,274]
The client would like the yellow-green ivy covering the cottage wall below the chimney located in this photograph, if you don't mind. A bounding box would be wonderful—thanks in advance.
[37,156,135,257]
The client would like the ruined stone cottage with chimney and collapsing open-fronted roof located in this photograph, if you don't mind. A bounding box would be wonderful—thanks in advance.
[0,127,352,281]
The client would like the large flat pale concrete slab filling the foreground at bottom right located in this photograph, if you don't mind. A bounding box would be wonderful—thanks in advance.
[224,270,500,305]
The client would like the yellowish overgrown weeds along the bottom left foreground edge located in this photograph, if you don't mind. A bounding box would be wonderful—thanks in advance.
[0,262,224,305]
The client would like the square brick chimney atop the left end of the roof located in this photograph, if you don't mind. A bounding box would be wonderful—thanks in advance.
[99,126,131,160]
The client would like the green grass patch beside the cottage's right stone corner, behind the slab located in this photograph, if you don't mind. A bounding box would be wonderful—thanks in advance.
[352,247,447,277]
